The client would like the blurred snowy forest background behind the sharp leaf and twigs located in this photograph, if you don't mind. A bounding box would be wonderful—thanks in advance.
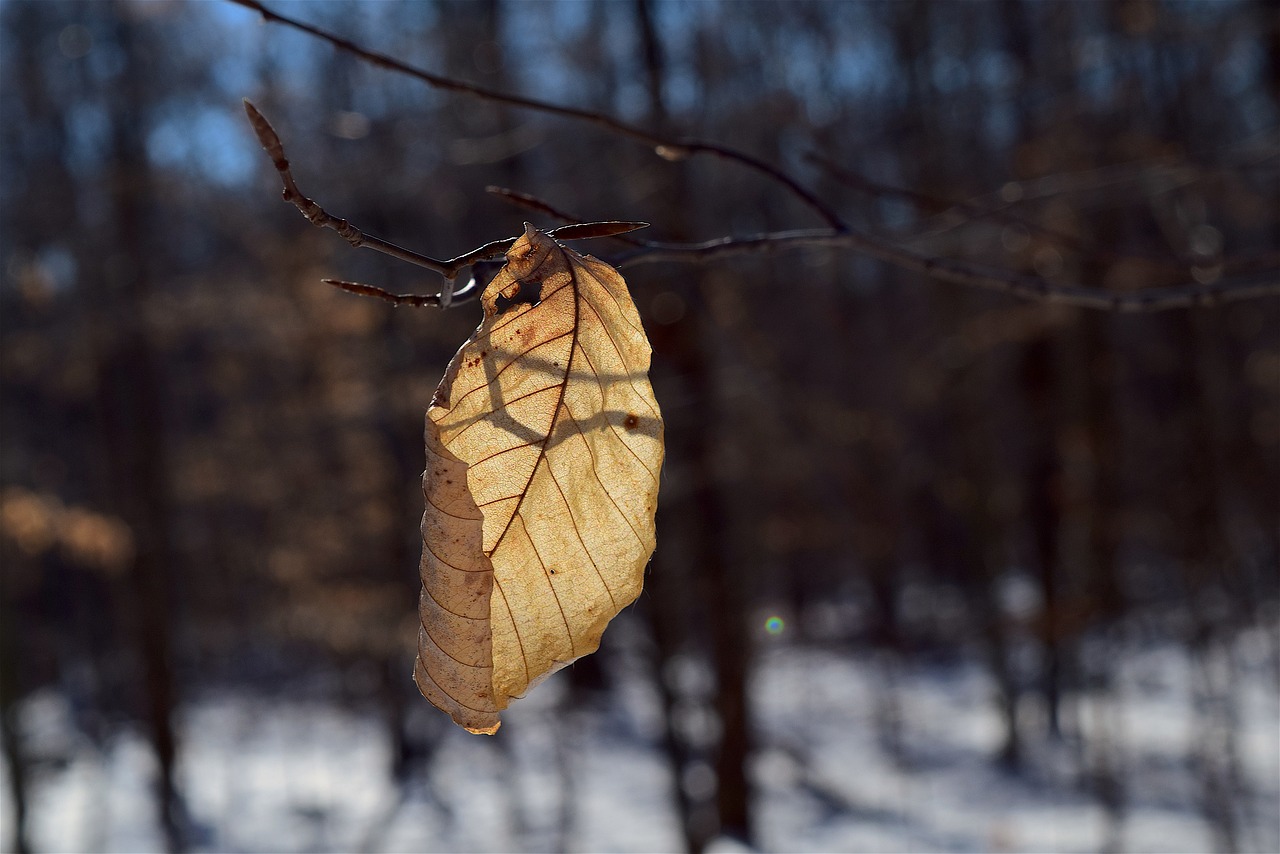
[0,0,1280,851]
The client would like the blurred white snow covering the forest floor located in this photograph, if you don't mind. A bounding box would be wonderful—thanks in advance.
[0,624,1280,853]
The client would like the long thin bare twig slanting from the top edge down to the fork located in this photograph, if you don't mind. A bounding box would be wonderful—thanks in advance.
[230,0,845,232]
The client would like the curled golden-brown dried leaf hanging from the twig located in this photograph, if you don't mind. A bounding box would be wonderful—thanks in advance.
[413,225,663,734]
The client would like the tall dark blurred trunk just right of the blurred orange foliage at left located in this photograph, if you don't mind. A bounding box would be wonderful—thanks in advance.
[82,5,186,851]
